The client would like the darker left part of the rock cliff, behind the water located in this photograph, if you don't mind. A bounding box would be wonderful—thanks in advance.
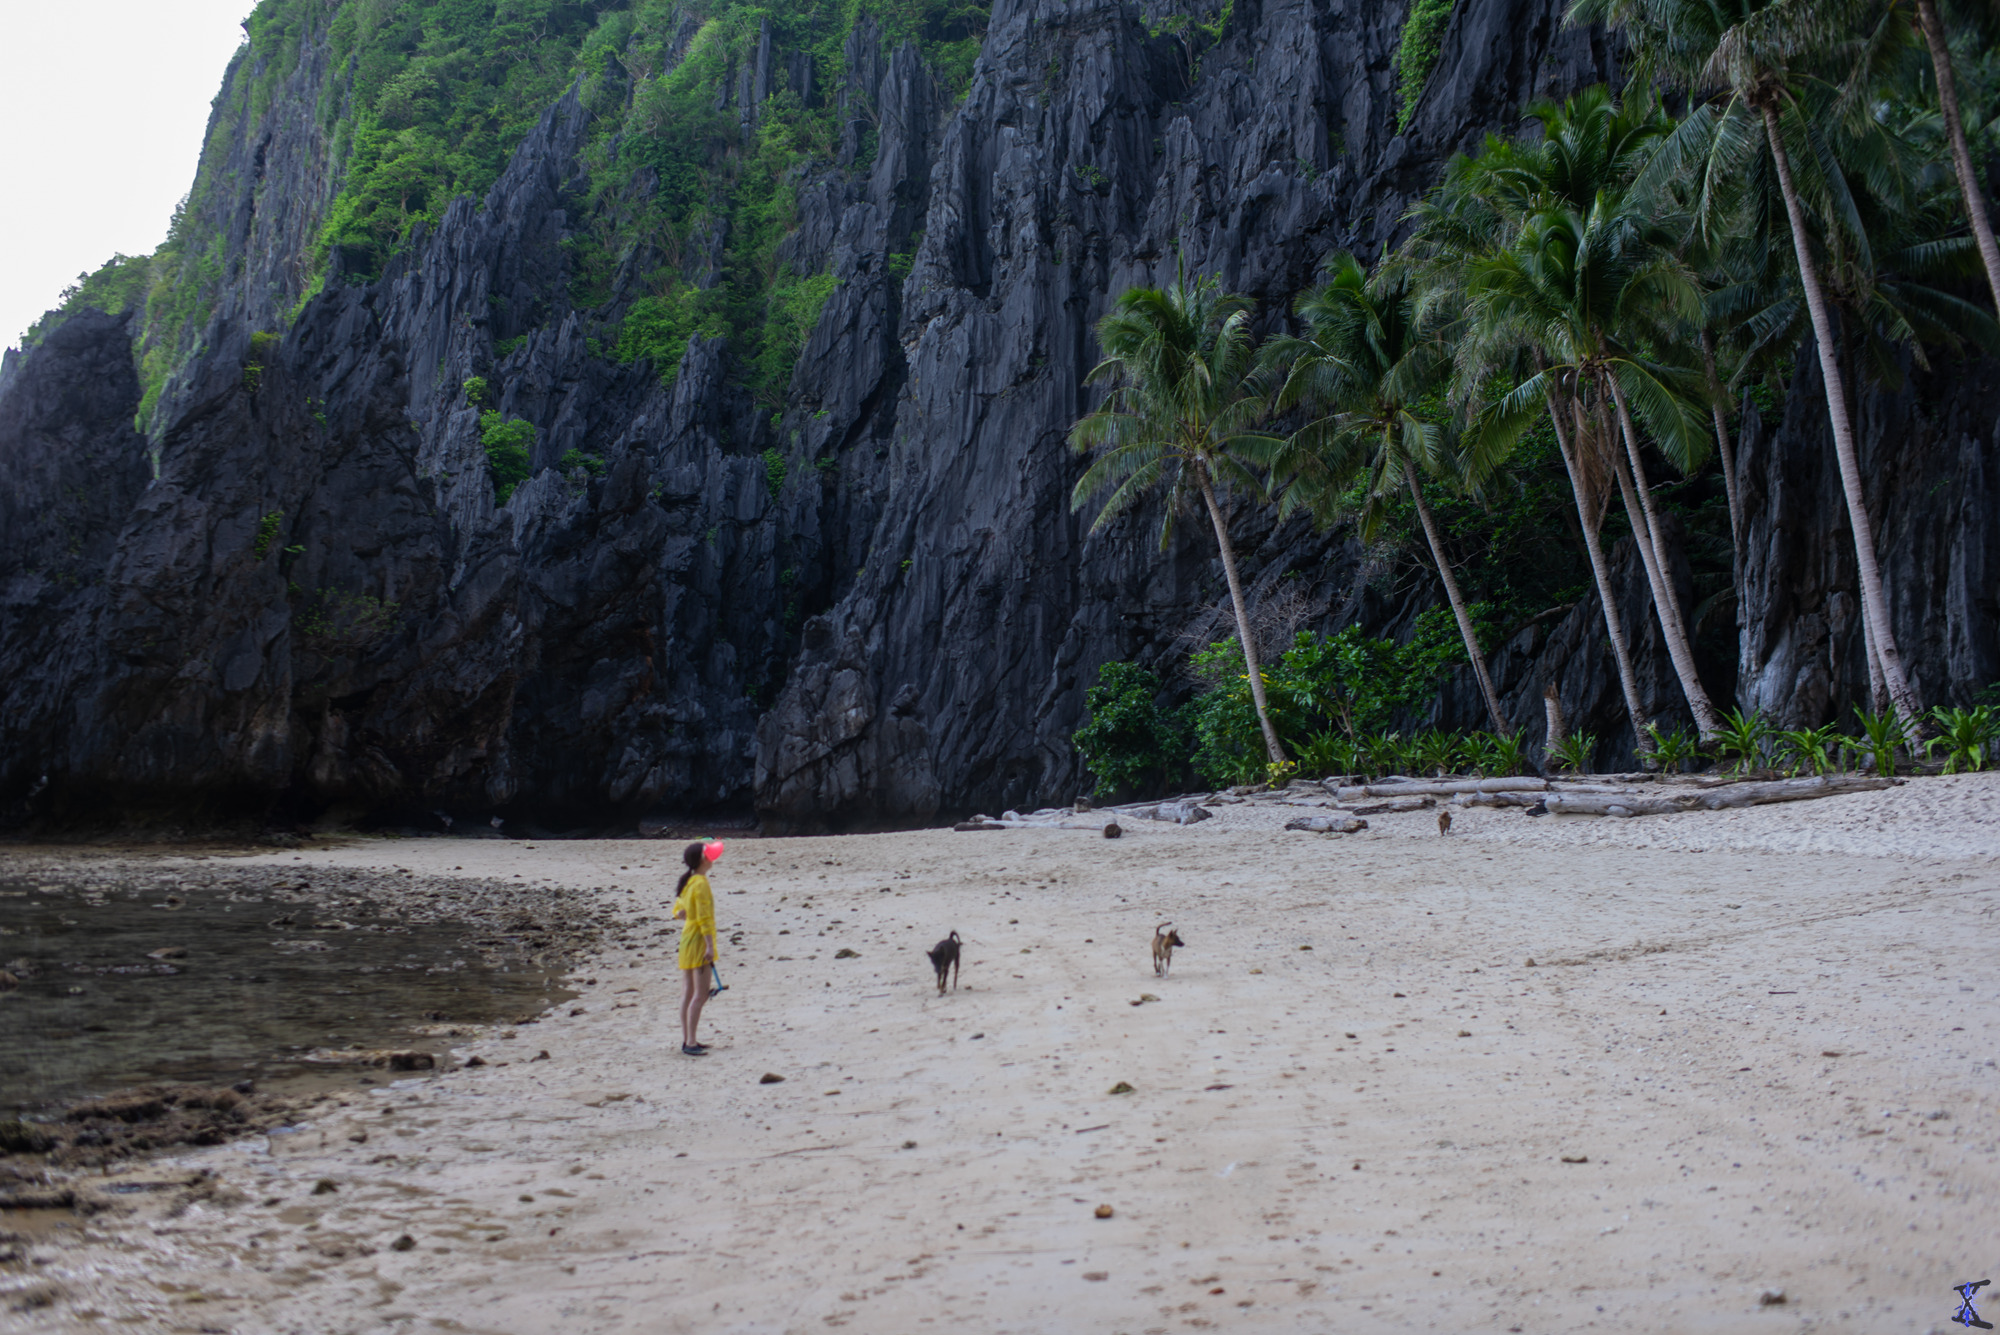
[0,93,800,823]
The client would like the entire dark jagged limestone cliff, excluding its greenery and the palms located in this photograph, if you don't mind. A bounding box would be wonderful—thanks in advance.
[0,0,2000,829]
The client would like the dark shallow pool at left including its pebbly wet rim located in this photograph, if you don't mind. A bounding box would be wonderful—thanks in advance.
[0,845,596,1119]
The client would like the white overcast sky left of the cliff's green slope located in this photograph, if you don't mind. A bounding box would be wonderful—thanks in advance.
[0,0,256,346]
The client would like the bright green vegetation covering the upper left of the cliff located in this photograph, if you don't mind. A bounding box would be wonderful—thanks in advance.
[41,0,990,428]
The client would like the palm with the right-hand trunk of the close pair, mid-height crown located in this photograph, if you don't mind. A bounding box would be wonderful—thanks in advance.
[1466,200,1722,737]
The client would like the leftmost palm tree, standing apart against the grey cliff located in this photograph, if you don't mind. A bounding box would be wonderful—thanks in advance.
[1070,276,1284,765]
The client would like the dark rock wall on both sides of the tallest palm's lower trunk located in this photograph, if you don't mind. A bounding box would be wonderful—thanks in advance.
[1738,344,2000,731]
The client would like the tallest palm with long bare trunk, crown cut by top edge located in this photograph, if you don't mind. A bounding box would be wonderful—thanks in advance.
[1570,0,1924,735]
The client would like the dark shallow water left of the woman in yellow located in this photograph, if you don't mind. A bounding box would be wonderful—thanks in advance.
[0,879,574,1115]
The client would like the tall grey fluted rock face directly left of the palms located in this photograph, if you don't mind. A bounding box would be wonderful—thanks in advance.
[758,0,1616,827]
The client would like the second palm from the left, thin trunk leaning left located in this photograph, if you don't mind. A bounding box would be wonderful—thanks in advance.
[1268,254,1512,735]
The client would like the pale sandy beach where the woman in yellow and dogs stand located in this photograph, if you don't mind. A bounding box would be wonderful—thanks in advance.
[0,775,2000,1335]
